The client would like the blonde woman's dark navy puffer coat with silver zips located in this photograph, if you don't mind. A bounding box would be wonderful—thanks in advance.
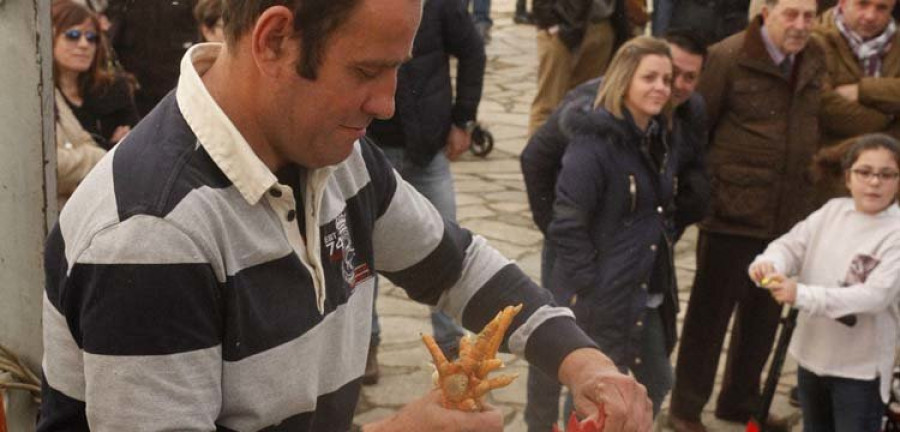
[549,98,693,370]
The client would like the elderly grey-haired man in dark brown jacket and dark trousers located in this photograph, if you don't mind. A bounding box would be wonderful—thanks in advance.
[670,0,825,431]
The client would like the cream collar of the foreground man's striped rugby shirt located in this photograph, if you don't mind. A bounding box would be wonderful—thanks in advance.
[175,43,278,205]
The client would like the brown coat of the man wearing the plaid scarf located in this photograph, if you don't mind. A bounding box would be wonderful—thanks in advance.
[813,5,900,146]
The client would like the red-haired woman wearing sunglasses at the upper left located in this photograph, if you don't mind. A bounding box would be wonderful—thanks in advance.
[51,0,139,207]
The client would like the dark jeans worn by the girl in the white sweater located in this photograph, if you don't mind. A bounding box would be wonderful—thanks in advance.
[797,367,884,432]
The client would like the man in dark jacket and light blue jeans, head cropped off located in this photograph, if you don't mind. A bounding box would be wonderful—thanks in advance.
[367,0,485,375]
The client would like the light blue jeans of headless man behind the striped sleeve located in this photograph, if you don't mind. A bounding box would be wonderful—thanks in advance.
[372,147,464,353]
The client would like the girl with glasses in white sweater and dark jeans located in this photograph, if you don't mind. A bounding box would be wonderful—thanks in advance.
[748,134,900,432]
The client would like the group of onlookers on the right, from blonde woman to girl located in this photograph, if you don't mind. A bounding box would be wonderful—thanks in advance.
[522,0,900,431]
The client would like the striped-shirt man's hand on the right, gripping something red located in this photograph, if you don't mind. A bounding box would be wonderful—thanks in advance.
[559,348,653,432]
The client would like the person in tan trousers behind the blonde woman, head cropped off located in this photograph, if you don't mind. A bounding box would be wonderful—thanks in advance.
[528,0,630,134]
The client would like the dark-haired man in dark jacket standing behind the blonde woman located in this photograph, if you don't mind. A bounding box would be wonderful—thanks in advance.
[521,32,709,431]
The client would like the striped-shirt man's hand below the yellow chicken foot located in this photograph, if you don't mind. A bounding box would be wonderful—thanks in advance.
[363,390,503,432]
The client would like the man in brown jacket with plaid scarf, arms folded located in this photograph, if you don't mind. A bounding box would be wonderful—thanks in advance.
[813,0,900,145]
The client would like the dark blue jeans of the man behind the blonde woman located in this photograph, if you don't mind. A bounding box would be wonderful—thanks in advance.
[525,239,568,432]
